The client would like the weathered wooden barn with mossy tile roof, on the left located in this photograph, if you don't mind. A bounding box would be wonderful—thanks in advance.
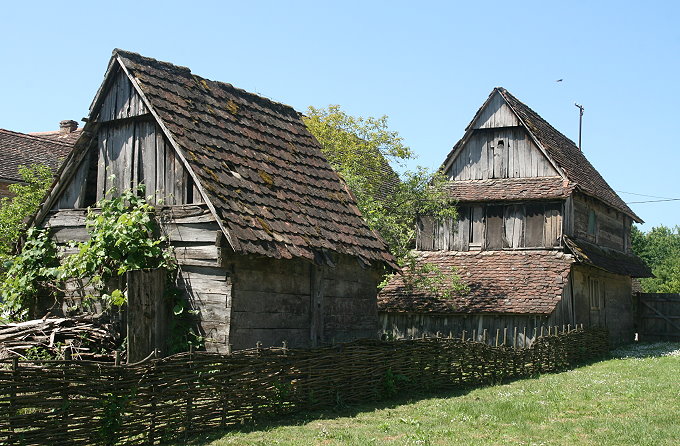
[30,50,393,352]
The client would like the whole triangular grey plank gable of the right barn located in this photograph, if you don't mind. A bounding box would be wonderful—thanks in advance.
[442,89,563,180]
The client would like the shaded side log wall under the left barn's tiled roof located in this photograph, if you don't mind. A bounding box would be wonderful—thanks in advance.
[224,255,379,349]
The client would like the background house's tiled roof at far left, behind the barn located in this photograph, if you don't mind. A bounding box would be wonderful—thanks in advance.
[0,129,72,182]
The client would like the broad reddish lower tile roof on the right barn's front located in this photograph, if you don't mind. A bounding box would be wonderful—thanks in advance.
[378,250,574,314]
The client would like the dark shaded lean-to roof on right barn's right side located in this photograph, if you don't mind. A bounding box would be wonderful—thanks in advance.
[564,236,653,277]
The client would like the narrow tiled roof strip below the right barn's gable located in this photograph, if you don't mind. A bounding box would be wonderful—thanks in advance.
[446,177,575,202]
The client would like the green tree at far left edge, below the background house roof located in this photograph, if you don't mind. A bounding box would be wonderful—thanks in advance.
[0,164,53,258]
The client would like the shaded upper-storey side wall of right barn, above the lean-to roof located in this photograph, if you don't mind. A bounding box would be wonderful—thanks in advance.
[567,194,632,252]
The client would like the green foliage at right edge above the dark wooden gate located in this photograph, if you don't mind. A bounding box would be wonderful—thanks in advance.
[631,225,680,293]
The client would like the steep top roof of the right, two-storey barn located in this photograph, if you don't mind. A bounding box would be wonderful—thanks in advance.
[444,87,642,223]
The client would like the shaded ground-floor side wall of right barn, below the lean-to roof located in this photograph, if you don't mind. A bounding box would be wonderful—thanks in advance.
[571,265,635,344]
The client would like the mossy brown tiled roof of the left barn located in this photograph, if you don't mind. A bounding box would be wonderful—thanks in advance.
[86,50,394,265]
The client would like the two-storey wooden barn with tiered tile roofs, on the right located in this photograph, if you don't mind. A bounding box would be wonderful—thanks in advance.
[378,88,650,342]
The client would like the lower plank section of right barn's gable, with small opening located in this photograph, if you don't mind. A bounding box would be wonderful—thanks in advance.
[447,127,558,180]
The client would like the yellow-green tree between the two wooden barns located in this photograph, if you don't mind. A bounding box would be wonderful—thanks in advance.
[304,105,464,297]
